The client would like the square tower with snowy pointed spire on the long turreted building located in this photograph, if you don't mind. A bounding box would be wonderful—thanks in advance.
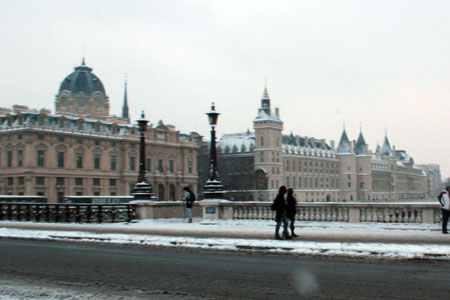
[253,86,284,201]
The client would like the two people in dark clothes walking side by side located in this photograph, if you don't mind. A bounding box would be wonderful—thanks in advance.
[272,185,297,240]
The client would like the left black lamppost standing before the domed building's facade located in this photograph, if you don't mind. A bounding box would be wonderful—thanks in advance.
[133,111,153,200]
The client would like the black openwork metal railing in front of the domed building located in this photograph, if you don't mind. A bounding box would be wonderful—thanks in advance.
[0,203,136,223]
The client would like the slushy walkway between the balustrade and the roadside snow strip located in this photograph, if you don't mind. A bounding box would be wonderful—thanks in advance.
[0,219,450,245]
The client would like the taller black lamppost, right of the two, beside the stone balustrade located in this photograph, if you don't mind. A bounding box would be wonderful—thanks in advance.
[203,102,225,199]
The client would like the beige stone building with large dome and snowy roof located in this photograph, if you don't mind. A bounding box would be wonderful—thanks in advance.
[0,59,200,202]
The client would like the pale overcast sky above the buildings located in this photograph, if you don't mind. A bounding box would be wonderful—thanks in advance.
[0,0,450,177]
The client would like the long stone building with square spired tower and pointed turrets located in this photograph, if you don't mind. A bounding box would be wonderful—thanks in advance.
[199,88,426,201]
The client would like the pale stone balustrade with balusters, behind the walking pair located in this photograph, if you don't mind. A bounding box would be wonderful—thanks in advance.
[199,200,441,224]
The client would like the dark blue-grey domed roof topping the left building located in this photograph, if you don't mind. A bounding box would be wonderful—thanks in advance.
[59,58,106,96]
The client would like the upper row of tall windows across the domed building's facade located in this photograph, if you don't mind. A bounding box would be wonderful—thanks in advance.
[2,150,194,173]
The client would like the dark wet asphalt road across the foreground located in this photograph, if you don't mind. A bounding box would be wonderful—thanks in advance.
[0,239,450,300]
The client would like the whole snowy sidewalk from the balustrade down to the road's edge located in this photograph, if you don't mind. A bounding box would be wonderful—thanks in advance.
[0,219,450,260]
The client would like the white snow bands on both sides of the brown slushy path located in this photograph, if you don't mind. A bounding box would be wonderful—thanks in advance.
[0,219,450,260]
